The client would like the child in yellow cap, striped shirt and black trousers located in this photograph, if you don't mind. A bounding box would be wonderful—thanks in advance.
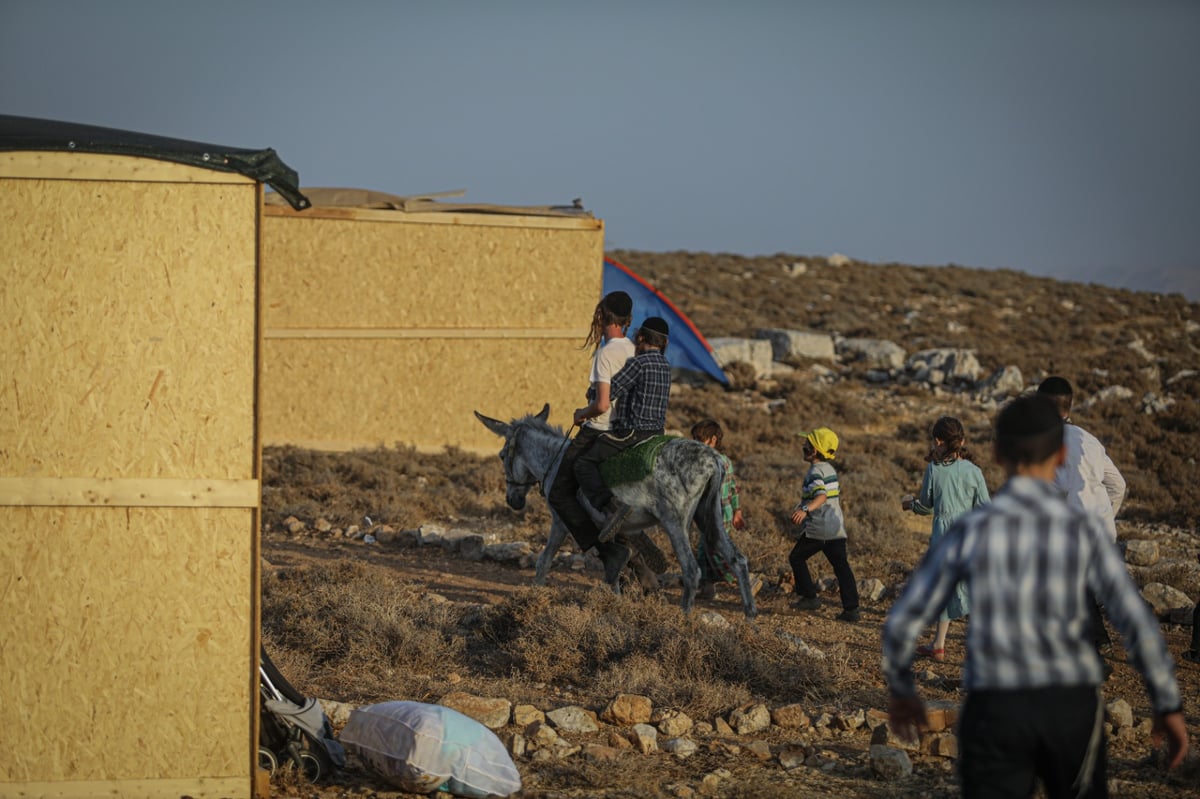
[787,427,859,621]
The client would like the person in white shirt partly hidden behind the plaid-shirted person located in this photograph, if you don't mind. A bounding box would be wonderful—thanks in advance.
[1038,376,1126,652]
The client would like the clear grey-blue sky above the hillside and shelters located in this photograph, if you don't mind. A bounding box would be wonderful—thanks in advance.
[0,0,1200,301]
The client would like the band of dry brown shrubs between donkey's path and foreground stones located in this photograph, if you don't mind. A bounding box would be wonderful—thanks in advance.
[263,560,830,717]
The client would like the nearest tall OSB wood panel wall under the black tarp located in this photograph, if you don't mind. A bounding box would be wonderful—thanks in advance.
[0,154,260,797]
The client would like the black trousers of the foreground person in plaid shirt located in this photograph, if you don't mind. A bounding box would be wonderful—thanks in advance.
[959,685,1109,799]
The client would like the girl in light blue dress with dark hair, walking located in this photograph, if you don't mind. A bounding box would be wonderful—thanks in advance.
[900,416,991,661]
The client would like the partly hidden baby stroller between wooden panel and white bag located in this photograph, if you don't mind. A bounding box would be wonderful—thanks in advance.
[258,649,346,782]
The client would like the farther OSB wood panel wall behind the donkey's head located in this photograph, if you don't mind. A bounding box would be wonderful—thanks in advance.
[262,208,604,452]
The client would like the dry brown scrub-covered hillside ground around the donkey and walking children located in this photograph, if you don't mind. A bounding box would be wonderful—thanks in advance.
[263,252,1200,799]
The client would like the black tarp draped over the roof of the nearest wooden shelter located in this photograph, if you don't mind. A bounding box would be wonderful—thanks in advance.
[0,114,310,211]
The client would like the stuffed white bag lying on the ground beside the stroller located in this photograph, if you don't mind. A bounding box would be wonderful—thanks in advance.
[338,702,521,799]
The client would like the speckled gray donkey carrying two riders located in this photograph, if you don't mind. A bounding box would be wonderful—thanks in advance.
[475,404,758,619]
